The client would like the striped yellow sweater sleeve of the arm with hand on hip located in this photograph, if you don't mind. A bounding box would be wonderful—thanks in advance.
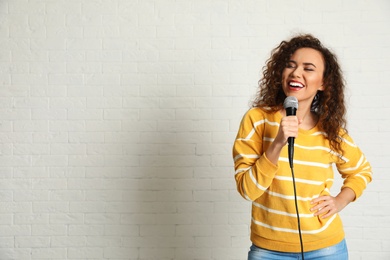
[337,134,372,200]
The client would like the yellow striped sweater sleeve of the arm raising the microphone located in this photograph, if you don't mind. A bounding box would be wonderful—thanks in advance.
[233,109,278,201]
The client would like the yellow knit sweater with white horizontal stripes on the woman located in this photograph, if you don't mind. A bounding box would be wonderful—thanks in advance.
[233,108,371,252]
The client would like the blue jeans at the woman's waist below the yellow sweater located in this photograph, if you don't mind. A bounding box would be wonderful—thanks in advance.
[248,239,348,260]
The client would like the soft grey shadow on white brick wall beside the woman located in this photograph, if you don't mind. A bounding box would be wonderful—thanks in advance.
[128,98,250,260]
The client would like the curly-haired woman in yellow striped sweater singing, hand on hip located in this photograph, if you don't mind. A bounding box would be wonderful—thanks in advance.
[233,35,371,260]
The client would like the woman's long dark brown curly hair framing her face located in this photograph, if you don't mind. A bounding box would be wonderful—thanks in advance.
[252,34,347,154]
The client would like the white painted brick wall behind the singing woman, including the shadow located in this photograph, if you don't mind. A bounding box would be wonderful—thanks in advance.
[0,0,390,260]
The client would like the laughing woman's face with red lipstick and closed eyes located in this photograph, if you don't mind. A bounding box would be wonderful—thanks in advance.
[282,48,325,105]
